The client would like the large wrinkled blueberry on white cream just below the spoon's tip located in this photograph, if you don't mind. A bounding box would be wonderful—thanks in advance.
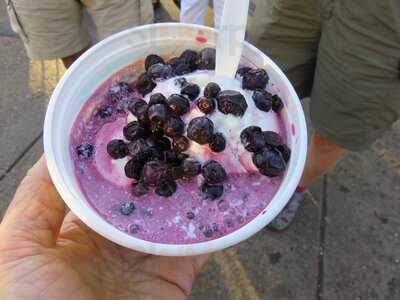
[217,90,247,117]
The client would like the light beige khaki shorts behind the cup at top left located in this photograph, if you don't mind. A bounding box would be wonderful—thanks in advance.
[6,0,153,59]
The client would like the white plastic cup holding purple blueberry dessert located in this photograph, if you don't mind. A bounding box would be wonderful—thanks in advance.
[44,23,307,256]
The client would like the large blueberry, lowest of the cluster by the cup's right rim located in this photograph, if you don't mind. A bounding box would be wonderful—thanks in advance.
[253,148,286,177]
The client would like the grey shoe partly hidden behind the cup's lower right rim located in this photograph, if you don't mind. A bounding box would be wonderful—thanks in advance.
[267,191,304,231]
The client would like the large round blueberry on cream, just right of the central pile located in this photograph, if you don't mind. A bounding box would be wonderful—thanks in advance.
[187,117,214,145]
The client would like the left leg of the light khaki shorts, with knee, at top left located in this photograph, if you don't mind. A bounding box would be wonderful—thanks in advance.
[7,0,90,65]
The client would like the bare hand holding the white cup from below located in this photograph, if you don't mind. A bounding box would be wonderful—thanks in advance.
[0,158,208,300]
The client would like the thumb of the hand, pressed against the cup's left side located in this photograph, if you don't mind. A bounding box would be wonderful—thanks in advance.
[1,157,65,246]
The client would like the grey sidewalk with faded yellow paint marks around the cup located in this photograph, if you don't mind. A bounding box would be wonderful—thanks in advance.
[0,0,400,300]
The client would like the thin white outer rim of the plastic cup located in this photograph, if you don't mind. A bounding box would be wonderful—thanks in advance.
[43,23,307,256]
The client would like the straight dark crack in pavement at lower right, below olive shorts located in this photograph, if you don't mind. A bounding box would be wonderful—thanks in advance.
[316,175,328,300]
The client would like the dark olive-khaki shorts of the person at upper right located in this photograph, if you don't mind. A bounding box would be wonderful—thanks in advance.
[248,0,400,151]
